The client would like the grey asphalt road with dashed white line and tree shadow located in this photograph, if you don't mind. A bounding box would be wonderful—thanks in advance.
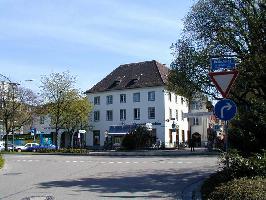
[0,155,218,200]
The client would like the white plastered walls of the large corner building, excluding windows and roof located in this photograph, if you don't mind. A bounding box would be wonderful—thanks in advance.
[86,86,188,146]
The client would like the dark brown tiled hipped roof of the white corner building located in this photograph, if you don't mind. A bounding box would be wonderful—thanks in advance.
[86,60,169,93]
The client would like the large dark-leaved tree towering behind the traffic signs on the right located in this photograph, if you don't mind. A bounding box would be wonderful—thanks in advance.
[168,0,266,151]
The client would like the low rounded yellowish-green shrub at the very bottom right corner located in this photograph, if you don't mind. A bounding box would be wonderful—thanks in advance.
[208,177,266,200]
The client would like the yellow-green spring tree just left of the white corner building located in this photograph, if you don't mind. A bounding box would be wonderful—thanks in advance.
[41,72,91,147]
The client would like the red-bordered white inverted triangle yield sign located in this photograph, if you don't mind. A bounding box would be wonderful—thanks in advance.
[209,70,238,98]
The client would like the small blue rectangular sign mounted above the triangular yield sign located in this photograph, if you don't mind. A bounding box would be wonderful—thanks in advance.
[211,58,236,71]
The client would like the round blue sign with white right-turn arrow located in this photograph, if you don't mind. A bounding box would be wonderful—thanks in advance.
[214,99,237,120]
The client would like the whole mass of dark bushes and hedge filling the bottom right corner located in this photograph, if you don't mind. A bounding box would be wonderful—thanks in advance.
[201,151,266,200]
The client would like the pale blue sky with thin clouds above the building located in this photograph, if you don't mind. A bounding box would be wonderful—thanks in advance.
[0,0,195,92]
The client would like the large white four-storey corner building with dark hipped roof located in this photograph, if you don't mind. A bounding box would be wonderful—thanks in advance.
[86,60,189,147]
